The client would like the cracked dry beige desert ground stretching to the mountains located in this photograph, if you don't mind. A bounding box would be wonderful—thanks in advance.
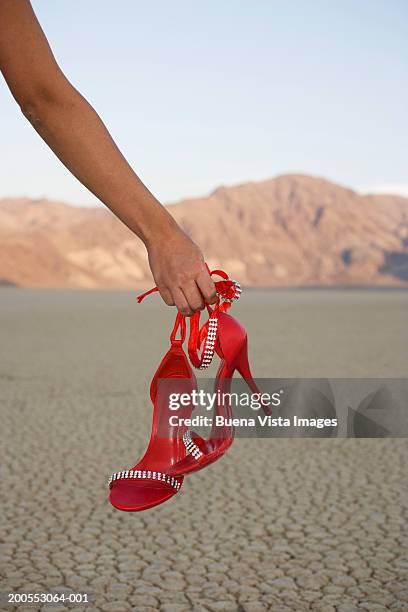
[0,289,408,612]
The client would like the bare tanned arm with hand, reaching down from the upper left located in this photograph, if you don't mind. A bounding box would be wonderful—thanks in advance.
[0,0,215,315]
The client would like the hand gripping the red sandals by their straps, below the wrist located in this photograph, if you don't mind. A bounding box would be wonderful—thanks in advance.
[146,223,217,316]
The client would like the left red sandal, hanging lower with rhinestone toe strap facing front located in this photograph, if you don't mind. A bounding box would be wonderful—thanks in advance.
[109,314,197,512]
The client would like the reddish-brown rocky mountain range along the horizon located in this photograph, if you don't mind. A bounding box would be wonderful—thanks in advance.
[0,174,408,288]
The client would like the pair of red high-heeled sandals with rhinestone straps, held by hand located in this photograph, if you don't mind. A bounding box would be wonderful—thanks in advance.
[109,270,270,512]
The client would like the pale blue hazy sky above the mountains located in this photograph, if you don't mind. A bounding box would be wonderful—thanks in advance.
[0,0,408,205]
